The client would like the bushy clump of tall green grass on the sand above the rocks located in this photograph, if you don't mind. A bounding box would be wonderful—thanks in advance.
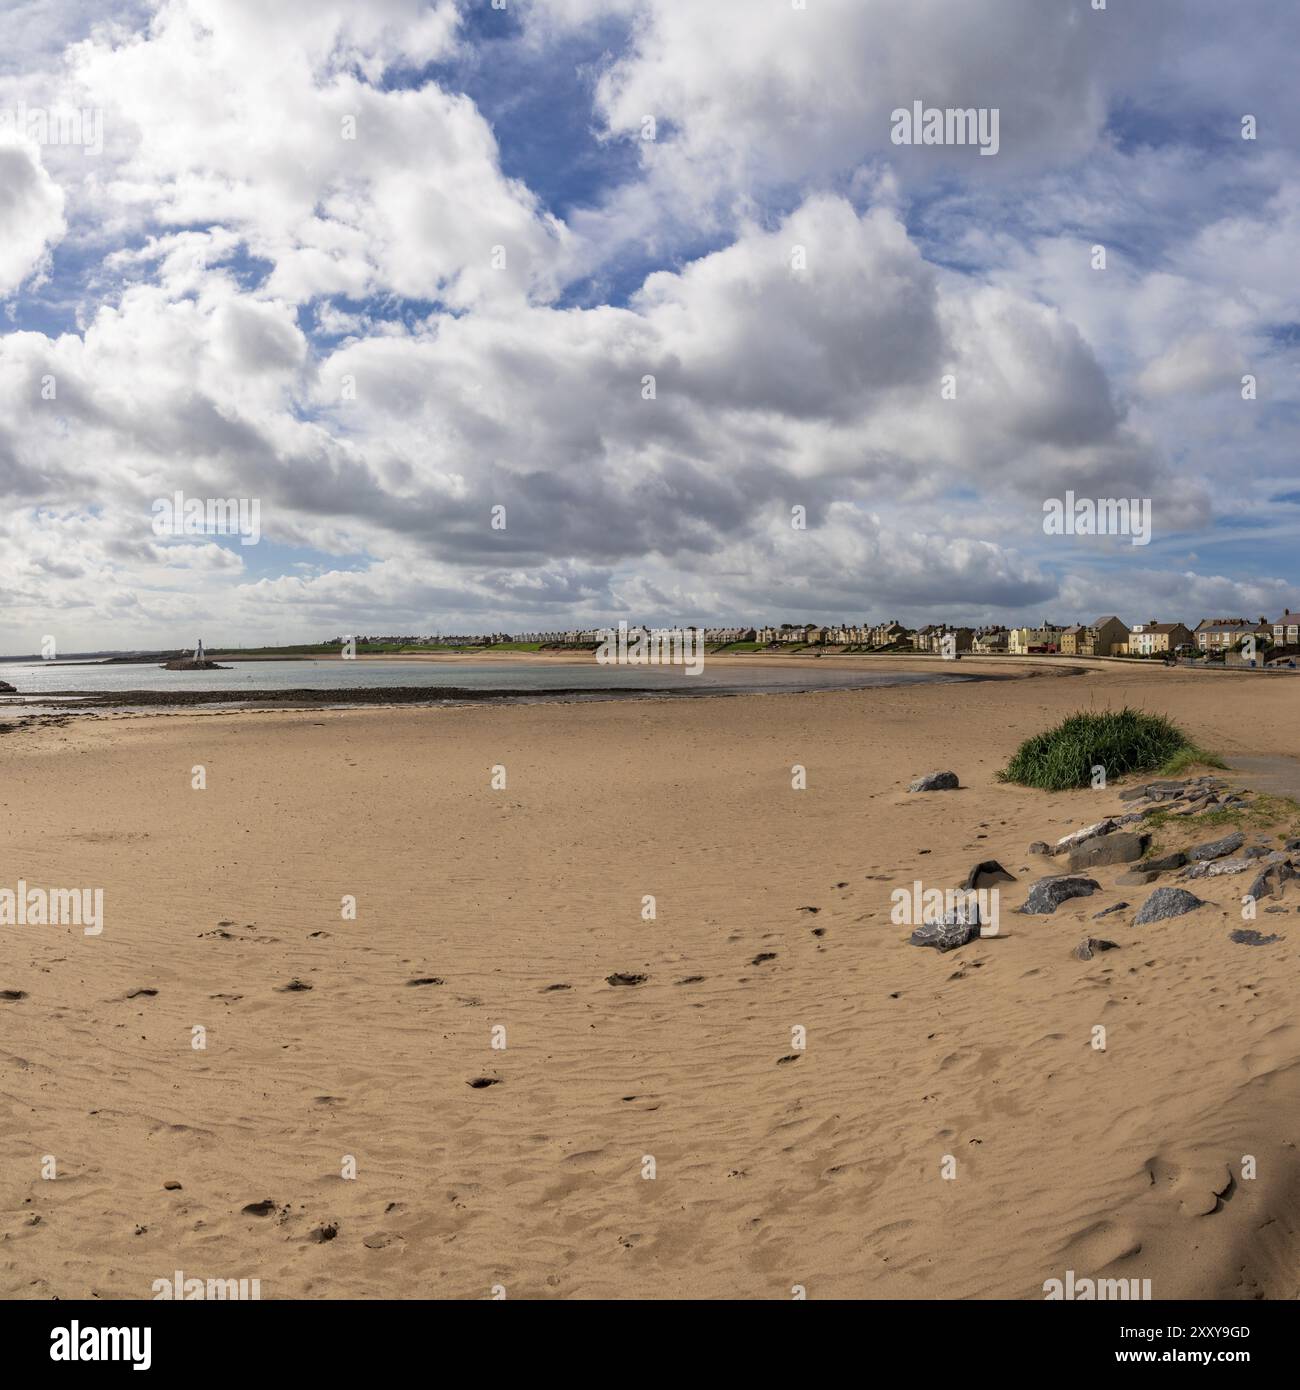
[998,709,1222,791]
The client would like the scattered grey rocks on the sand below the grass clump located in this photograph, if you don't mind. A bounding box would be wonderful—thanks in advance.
[908,773,1300,960]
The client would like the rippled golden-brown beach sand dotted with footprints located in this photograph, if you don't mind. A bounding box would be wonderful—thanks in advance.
[0,662,1300,1298]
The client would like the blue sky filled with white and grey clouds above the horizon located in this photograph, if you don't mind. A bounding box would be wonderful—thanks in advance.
[0,0,1300,655]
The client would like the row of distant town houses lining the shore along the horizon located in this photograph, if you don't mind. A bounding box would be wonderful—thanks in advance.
[346,609,1300,667]
